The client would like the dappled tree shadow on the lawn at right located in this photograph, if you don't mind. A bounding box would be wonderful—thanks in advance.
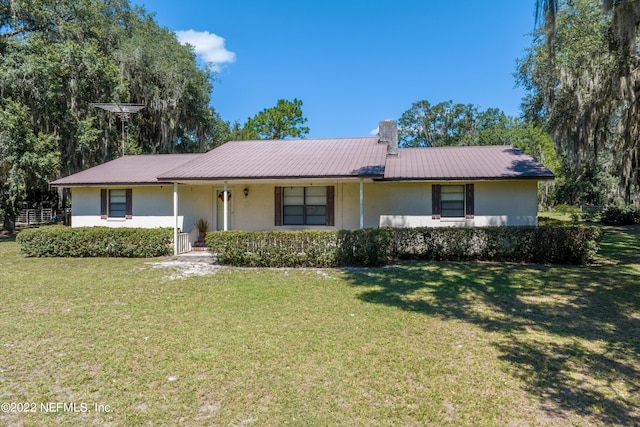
[347,227,640,425]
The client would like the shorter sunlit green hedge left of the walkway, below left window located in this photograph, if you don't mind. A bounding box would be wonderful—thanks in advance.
[16,225,173,258]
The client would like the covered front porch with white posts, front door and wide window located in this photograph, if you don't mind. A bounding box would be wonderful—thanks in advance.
[173,179,378,255]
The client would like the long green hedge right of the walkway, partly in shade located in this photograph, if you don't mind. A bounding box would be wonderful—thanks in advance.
[207,226,602,267]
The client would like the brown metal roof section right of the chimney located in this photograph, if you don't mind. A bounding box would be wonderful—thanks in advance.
[384,145,554,180]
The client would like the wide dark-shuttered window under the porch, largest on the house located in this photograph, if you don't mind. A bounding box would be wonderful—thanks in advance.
[275,186,334,225]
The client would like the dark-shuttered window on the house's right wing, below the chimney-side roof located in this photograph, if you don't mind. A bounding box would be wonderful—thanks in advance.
[431,184,474,219]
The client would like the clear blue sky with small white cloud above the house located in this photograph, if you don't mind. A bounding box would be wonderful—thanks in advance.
[133,0,534,138]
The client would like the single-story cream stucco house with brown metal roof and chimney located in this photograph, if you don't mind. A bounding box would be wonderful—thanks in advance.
[51,121,554,252]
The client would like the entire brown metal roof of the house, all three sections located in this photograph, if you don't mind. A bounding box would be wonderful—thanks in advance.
[51,141,554,187]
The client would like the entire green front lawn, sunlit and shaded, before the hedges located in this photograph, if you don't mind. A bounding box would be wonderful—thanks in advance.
[0,229,640,426]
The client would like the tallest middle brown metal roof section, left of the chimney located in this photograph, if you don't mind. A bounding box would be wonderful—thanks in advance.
[160,137,387,180]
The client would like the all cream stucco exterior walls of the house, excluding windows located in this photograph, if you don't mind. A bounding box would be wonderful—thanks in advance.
[72,180,537,232]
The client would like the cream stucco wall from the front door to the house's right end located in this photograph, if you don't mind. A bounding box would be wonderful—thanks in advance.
[216,181,538,231]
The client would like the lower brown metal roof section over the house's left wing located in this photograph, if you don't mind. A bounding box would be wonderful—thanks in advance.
[51,154,202,187]
